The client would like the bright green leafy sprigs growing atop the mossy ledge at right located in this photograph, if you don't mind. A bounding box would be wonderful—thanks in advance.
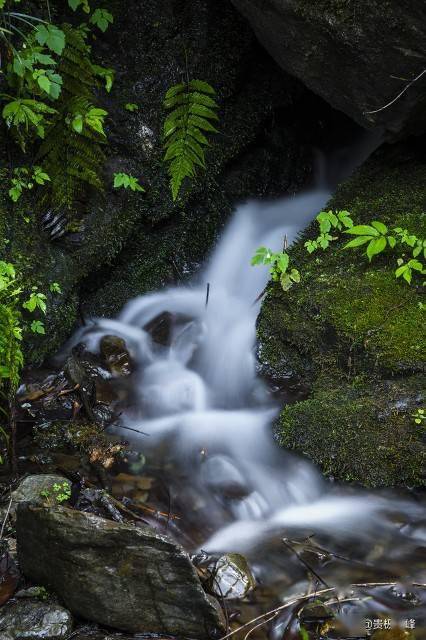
[304,211,426,284]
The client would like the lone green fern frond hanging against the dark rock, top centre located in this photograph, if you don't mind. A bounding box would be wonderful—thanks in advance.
[164,80,219,200]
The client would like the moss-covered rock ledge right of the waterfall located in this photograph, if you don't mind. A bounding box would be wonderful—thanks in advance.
[258,140,426,487]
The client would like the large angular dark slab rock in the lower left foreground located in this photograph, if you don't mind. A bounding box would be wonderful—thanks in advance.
[17,504,224,639]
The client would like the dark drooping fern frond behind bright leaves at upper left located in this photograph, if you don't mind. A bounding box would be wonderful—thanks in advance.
[37,25,106,209]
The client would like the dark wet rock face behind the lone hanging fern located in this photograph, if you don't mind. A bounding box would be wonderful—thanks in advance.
[0,0,324,362]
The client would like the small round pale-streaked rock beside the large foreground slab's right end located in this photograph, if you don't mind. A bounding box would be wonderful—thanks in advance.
[209,553,256,600]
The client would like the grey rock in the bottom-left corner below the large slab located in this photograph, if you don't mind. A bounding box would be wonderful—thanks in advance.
[0,600,73,640]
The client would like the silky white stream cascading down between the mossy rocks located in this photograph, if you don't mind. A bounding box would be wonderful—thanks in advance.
[68,190,426,638]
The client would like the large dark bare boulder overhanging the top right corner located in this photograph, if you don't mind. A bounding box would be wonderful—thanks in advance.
[232,0,426,133]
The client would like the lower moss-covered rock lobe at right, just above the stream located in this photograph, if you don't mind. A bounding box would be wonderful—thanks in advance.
[277,377,426,487]
